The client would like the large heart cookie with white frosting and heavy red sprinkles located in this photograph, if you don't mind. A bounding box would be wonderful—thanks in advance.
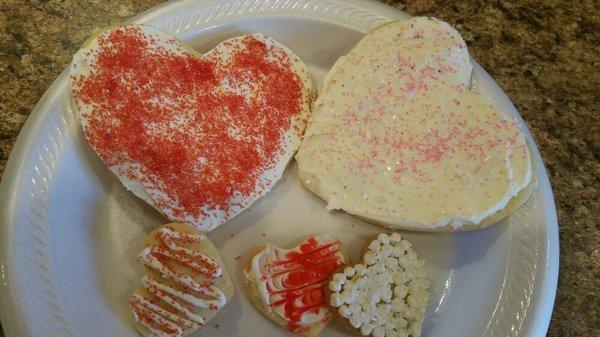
[71,26,313,231]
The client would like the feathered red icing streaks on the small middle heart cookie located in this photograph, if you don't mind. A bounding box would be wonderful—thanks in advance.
[265,237,344,333]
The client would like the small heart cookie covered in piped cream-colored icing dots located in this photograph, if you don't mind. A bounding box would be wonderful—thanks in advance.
[325,233,429,337]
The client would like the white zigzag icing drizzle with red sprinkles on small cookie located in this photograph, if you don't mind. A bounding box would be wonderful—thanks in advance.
[129,227,227,337]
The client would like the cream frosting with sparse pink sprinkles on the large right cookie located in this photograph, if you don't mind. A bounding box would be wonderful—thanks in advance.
[296,17,531,229]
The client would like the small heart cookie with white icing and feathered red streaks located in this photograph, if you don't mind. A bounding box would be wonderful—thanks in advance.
[245,234,347,336]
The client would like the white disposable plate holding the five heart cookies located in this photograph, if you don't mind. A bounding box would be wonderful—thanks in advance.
[0,0,558,337]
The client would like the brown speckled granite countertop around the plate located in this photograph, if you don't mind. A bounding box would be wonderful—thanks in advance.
[0,0,600,337]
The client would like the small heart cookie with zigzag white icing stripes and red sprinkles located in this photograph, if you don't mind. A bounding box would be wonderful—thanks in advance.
[129,223,234,337]
